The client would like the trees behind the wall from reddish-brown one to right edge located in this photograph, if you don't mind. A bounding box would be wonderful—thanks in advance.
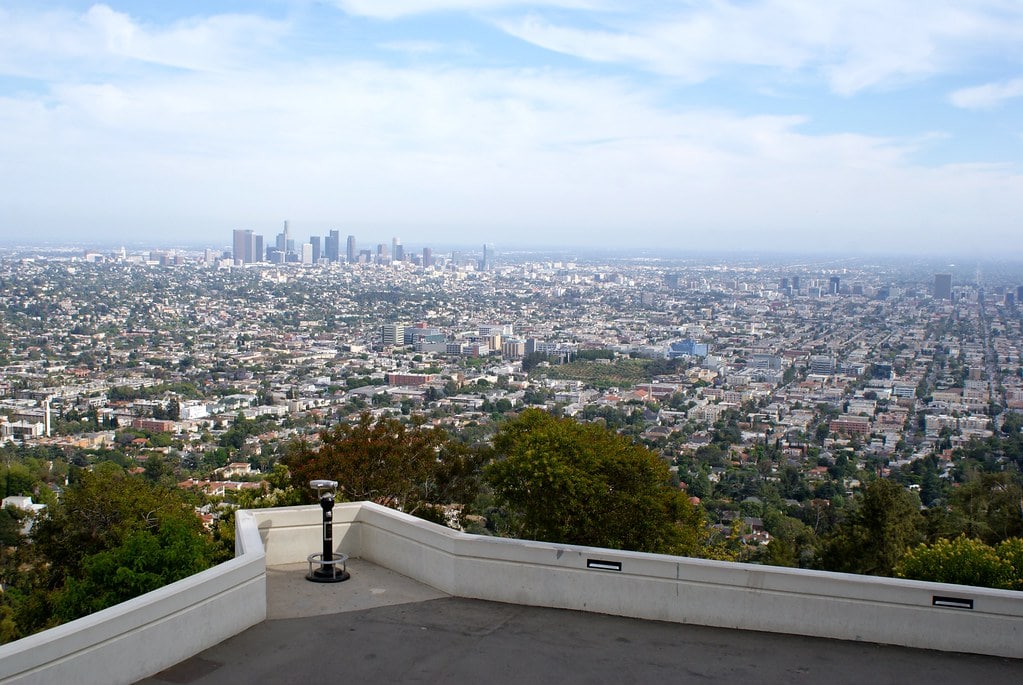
[286,409,1023,587]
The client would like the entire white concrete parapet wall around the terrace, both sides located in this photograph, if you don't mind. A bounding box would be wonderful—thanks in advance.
[0,503,1023,685]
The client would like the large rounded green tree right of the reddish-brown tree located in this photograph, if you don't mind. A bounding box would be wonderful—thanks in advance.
[485,409,703,554]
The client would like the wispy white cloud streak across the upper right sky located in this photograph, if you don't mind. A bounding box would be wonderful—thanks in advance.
[496,0,1023,95]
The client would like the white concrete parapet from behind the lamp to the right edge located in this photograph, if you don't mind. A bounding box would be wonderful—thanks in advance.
[247,503,1023,658]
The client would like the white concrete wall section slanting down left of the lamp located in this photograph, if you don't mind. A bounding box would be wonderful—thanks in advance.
[0,512,266,685]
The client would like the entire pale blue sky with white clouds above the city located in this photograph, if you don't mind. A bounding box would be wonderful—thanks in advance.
[0,0,1023,258]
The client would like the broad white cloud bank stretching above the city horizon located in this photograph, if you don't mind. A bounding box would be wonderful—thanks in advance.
[0,46,1023,248]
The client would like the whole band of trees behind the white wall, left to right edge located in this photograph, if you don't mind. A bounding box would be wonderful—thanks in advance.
[0,409,1023,640]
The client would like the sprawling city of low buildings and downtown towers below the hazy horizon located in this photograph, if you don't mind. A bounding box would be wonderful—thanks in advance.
[0,244,1023,539]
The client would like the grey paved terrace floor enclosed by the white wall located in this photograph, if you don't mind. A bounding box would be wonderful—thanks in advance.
[140,559,1023,685]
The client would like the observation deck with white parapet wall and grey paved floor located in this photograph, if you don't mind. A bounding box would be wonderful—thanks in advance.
[0,502,1023,685]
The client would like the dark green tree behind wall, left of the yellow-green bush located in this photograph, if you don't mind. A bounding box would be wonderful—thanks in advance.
[818,478,924,576]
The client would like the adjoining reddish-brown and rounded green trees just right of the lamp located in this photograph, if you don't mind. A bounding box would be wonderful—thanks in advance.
[285,409,708,554]
